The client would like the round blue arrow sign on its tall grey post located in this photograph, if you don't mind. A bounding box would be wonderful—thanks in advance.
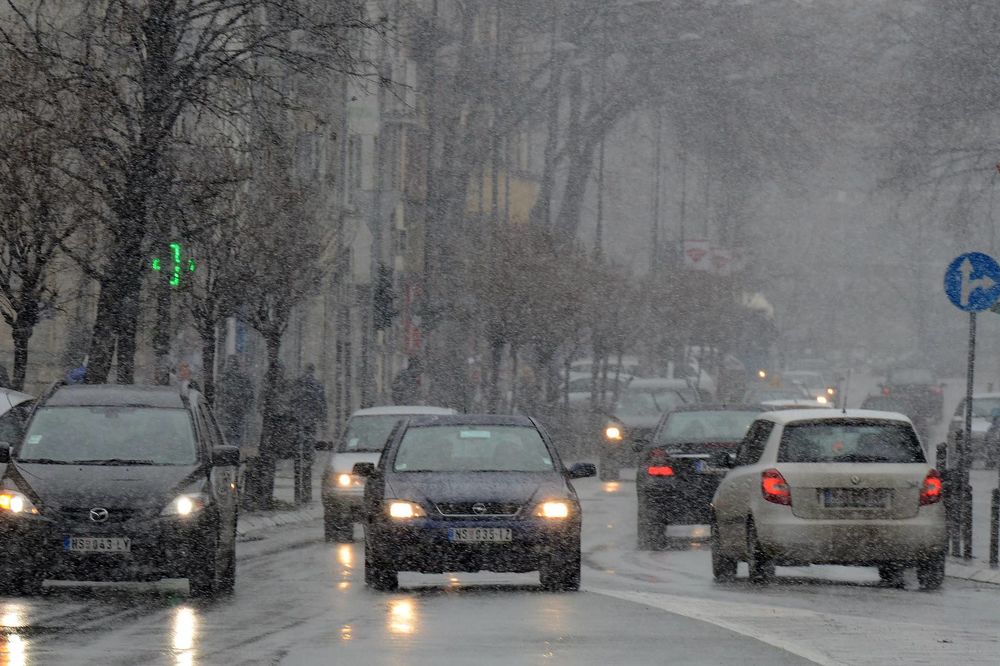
[944,252,1000,559]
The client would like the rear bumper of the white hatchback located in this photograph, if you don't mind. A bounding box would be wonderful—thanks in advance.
[755,504,947,565]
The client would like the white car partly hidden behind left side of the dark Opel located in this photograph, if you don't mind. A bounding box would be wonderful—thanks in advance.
[322,405,457,543]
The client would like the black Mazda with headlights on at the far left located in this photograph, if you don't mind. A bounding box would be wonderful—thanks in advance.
[0,385,240,597]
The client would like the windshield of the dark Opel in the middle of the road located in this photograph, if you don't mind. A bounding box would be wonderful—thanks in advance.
[393,425,554,472]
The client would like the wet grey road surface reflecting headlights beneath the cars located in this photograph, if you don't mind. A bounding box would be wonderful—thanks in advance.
[0,464,1000,665]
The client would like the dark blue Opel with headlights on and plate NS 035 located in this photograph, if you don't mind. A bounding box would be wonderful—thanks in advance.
[354,415,596,590]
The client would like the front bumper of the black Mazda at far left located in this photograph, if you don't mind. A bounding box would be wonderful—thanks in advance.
[0,512,217,581]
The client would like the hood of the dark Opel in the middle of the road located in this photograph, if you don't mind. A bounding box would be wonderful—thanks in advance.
[385,472,575,504]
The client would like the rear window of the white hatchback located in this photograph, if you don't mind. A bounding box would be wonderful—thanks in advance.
[778,421,925,463]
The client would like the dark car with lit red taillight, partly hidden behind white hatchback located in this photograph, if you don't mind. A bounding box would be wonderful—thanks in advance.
[635,404,763,550]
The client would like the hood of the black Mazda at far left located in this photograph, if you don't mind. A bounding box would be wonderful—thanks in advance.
[5,462,206,509]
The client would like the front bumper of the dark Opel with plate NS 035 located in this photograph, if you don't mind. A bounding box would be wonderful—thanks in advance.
[366,519,580,573]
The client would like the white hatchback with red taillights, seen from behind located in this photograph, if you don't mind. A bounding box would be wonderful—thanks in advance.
[712,409,947,589]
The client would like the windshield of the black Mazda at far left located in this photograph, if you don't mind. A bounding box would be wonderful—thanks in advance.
[18,407,198,465]
